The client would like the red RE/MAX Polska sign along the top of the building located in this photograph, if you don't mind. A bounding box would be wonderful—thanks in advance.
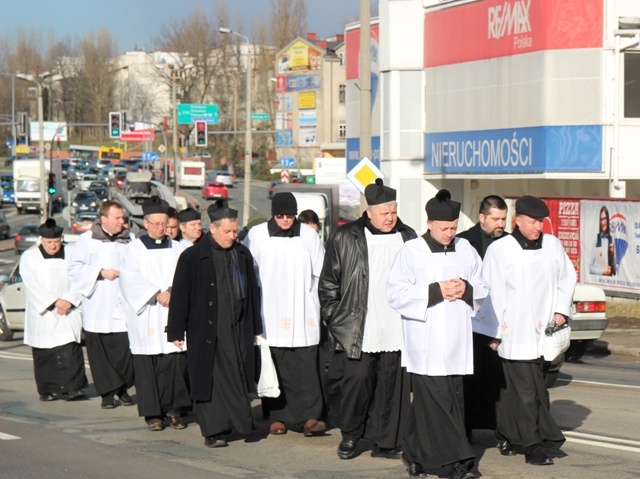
[424,0,604,68]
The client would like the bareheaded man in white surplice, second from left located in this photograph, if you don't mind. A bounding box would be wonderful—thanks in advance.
[69,200,133,409]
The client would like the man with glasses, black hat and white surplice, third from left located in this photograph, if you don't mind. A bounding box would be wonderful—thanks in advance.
[120,196,191,431]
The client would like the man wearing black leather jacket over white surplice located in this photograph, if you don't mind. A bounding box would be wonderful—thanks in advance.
[318,178,416,459]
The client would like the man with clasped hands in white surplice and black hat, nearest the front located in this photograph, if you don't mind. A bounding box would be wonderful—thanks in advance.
[387,190,488,479]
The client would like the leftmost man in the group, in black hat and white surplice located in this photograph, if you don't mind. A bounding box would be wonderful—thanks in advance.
[20,219,87,401]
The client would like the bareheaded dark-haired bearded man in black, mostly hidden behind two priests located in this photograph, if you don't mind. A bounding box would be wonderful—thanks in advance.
[457,195,509,446]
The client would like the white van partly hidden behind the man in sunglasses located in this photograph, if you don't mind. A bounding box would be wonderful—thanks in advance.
[273,183,340,243]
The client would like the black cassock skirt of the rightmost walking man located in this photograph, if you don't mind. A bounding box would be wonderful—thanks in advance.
[497,359,565,448]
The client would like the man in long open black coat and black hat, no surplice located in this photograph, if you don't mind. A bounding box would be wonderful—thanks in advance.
[167,200,262,447]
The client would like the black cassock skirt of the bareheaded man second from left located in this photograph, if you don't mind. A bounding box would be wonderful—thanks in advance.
[84,331,133,396]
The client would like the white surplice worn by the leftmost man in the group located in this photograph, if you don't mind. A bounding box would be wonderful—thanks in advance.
[20,245,82,349]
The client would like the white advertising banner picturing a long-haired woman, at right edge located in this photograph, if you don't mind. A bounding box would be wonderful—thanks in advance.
[580,200,640,293]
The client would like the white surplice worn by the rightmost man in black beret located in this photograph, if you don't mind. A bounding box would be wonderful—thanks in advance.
[474,235,576,360]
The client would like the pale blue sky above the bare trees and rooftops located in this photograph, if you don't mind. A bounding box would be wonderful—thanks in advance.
[0,0,360,52]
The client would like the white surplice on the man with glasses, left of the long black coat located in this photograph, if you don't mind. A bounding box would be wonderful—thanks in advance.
[120,238,186,355]
